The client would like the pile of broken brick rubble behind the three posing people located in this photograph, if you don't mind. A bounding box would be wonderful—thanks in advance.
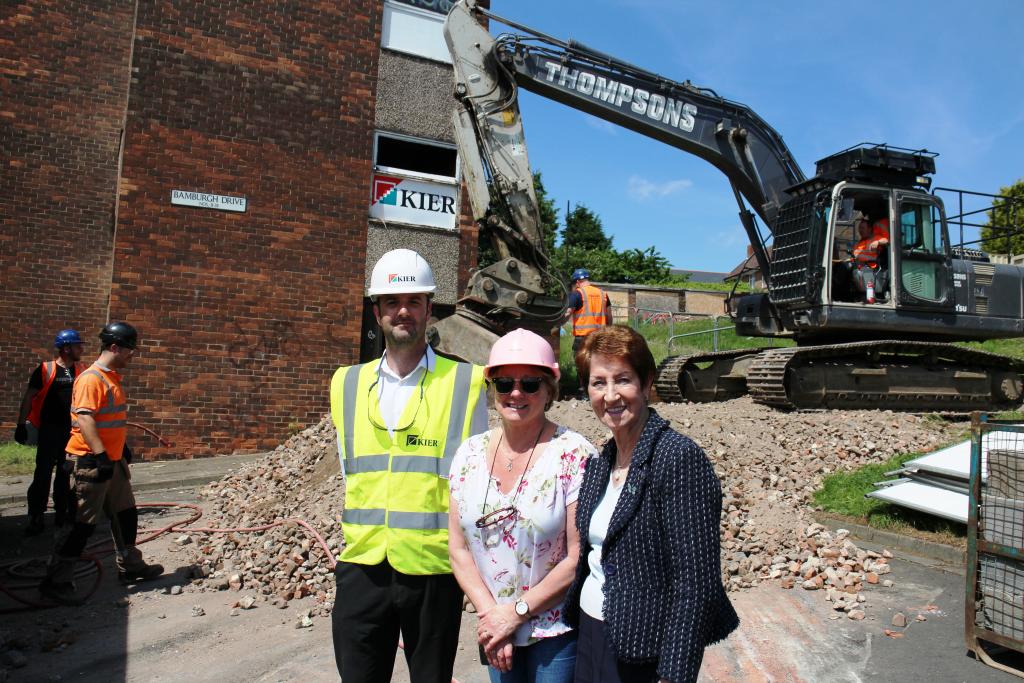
[182,398,958,618]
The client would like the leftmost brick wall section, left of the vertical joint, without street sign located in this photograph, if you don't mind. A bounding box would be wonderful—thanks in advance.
[0,0,134,428]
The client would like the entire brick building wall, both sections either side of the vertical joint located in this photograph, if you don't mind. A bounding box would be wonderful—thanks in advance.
[0,0,381,458]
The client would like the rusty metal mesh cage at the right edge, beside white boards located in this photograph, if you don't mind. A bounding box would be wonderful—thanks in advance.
[965,414,1024,677]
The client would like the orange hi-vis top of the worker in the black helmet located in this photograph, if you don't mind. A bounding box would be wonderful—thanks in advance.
[67,362,128,460]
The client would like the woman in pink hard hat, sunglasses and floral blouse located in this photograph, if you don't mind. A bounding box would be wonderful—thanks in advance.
[449,330,596,683]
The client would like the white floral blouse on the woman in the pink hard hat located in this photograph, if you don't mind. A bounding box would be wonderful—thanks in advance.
[449,426,597,645]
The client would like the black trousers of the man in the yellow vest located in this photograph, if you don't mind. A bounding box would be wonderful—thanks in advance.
[331,560,462,683]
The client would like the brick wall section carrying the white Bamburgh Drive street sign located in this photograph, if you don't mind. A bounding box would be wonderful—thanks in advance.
[111,0,381,457]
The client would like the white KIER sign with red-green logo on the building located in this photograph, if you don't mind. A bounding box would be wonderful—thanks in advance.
[370,173,459,230]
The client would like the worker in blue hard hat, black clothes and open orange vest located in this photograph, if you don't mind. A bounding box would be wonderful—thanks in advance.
[14,330,86,536]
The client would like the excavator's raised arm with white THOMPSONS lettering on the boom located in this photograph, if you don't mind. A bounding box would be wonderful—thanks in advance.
[432,0,805,361]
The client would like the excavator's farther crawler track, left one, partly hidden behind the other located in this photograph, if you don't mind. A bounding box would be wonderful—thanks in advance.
[654,348,762,402]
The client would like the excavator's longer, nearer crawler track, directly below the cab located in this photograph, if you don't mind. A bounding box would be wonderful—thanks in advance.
[746,341,1024,412]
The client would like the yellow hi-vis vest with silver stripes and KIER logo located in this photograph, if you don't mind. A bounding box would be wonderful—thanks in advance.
[331,355,487,574]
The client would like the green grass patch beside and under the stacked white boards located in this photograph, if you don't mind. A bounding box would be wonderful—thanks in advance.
[814,453,967,546]
